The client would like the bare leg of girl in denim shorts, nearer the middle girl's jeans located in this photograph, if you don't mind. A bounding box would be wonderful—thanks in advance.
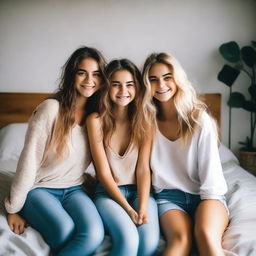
[160,210,192,256]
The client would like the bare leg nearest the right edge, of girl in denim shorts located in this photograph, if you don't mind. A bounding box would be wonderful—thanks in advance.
[195,200,229,256]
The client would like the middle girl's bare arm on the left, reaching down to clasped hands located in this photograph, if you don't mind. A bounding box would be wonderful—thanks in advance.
[86,113,137,224]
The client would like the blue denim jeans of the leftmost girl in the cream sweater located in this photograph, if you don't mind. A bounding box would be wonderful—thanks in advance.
[20,186,104,256]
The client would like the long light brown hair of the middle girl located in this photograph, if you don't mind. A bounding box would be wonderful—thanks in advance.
[99,59,149,145]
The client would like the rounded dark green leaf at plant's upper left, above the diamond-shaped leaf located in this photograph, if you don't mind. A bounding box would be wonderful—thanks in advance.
[219,41,240,62]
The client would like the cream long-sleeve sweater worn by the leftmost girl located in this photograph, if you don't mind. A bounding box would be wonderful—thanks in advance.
[5,99,91,213]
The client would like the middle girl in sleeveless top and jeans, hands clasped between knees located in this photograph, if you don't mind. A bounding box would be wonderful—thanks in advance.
[87,59,159,256]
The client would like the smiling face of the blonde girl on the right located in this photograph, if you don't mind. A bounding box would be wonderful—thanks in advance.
[149,63,177,102]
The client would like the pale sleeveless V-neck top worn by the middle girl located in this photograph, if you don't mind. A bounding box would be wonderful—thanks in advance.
[105,143,138,186]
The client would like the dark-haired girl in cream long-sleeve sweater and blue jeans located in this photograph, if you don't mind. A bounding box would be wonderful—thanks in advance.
[5,47,106,256]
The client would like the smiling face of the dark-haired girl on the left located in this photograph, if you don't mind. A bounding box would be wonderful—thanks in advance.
[75,58,102,98]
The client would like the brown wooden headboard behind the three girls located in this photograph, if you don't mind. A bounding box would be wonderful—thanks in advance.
[0,93,221,128]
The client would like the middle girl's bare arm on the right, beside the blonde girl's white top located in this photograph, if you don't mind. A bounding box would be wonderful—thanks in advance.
[136,129,152,225]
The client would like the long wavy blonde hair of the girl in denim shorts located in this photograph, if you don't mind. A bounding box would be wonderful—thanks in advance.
[142,53,218,144]
